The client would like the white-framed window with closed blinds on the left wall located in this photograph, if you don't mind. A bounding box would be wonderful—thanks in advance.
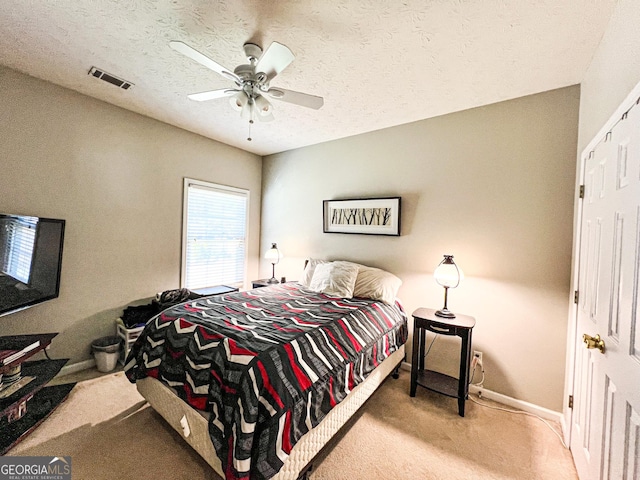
[182,178,249,290]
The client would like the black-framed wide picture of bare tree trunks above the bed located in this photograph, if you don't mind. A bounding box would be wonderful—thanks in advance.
[322,197,400,236]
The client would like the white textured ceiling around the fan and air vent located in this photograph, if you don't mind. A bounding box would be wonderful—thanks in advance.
[0,0,615,155]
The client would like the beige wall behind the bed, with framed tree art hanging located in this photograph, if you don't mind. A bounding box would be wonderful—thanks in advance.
[261,86,579,411]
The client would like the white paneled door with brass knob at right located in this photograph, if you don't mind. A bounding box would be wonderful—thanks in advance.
[571,91,640,480]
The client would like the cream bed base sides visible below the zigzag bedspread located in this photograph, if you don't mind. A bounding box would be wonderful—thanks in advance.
[136,345,405,480]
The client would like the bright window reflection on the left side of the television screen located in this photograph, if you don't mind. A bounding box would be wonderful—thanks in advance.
[0,217,38,284]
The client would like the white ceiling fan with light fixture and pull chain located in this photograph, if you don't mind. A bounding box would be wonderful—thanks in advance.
[169,41,324,141]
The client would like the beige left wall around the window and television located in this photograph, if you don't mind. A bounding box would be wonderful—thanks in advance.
[0,67,262,363]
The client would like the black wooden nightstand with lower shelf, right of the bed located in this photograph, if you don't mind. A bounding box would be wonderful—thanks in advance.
[410,308,476,417]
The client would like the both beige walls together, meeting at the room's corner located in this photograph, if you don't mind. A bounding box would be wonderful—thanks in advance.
[0,60,592,410]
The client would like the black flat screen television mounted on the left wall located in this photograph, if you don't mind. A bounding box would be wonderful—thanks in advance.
[0,214,65,316]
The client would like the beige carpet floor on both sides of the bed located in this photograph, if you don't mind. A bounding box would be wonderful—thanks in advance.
[7,371,578,480]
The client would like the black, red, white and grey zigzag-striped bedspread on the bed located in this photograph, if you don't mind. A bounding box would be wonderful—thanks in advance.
[125,283,407,479]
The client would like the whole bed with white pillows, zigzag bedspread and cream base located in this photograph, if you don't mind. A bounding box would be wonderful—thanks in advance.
[125,261,408,480]
